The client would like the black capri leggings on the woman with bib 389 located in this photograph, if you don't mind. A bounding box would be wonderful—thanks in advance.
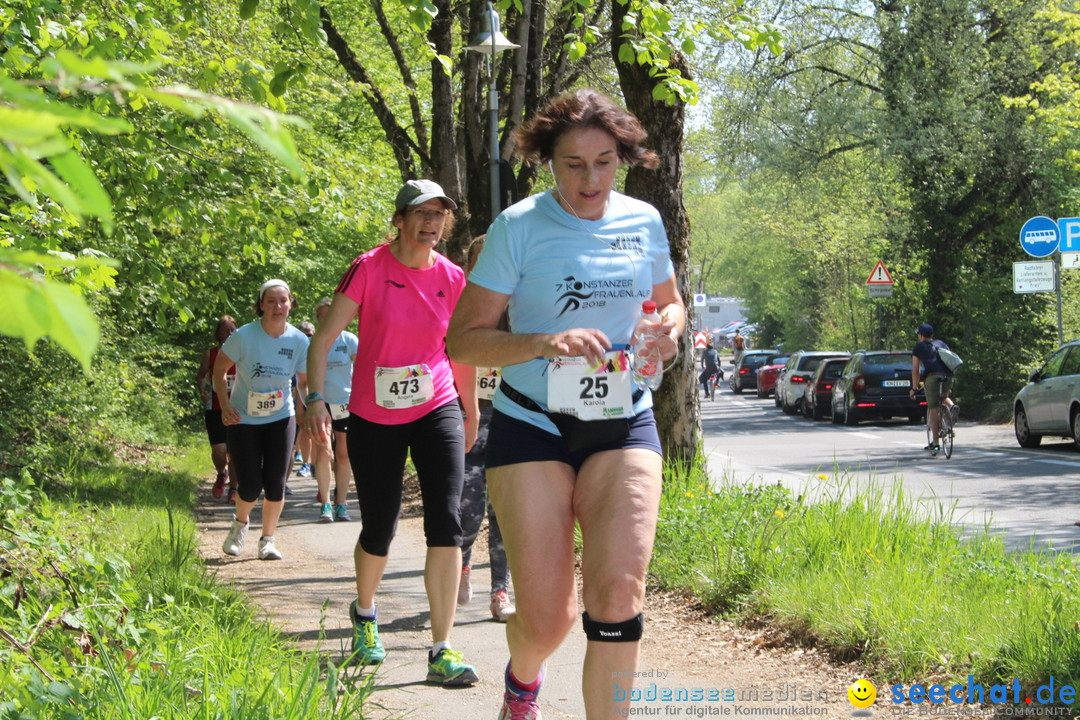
[225,416,296,503]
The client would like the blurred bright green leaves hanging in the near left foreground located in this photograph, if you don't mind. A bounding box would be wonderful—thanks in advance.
[0,0,313,369]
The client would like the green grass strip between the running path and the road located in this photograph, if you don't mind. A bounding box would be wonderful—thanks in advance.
[651,459,1080,687]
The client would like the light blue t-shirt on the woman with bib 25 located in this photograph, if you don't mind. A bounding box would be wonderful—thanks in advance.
[469,192,675,433]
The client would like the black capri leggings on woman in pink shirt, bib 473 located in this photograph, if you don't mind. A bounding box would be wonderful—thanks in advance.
[348,400,465,557]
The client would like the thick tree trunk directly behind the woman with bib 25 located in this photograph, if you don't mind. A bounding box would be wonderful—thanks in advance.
[611,2,700,461]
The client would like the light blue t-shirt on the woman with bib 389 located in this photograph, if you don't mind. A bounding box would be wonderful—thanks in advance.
[221,321,308,425]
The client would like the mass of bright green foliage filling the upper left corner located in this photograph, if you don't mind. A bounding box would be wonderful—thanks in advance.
[0,0,397,471]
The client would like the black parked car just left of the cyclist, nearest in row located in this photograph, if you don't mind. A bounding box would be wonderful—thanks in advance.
[831,350,927,425]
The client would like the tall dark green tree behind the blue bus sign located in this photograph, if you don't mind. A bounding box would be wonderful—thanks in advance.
[878,0,1063,403]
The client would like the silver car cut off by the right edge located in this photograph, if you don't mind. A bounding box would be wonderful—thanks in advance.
[1013,339,1080,448]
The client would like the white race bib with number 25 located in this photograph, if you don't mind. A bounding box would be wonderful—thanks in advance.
[548,350,634,420]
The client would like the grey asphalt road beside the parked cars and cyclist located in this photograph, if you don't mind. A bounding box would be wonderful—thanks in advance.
[701,386,1080,552]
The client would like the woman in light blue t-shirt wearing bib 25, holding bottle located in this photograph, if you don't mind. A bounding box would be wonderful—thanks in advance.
[447,90,686,720]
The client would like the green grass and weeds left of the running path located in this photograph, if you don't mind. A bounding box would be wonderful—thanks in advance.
[0,449,372,720]
